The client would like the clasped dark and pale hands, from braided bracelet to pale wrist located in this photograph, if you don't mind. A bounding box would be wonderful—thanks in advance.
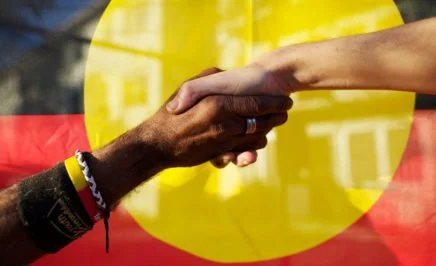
[88,65,294,206]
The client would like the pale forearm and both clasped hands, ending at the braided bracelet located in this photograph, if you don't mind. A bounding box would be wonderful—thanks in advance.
[91,18,436,206]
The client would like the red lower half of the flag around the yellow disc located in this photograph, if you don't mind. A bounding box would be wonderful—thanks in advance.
[0,111,436,266]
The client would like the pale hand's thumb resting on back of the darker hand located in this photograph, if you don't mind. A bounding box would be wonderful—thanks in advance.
[166,67,223,114]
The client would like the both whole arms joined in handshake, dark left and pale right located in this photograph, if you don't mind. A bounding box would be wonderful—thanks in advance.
[0,18,436,265]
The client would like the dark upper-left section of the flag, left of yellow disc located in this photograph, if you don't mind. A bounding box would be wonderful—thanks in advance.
[0,0,109,115]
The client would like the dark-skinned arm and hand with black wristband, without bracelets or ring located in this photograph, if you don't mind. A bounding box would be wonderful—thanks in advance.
[0,76,292,265]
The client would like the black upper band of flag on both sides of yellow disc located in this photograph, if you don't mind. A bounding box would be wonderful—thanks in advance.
[0,0,436,114]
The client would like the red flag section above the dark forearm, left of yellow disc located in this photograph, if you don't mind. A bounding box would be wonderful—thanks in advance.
[0,115,89,187]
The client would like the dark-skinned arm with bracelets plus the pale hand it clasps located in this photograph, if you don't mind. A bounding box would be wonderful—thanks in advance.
[0,65,292,265]
